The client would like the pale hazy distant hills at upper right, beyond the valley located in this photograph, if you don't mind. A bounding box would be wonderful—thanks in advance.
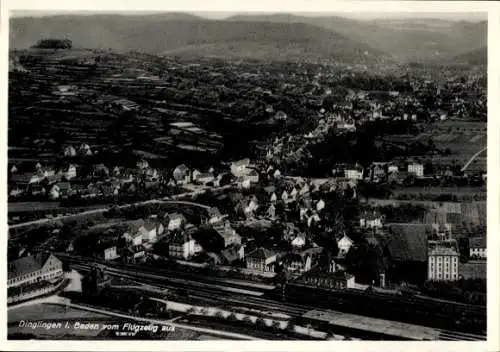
[228,14,487,61]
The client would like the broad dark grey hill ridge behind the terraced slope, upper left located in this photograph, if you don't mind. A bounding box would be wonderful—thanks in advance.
[9,14,390,63]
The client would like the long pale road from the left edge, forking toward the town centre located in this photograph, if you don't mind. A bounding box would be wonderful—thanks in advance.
[9,185,233,230]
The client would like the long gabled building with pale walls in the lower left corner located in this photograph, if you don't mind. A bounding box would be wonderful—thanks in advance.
[7,253,64,288]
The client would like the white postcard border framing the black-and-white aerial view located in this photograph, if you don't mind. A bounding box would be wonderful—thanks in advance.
[0,0,500,352]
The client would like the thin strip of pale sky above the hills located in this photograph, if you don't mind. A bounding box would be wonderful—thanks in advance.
[11,10,487,22]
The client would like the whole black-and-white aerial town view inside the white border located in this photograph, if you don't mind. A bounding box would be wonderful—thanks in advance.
[6,11,488,342]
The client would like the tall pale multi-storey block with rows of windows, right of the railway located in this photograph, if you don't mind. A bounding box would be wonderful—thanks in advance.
[428,240,460,281]
